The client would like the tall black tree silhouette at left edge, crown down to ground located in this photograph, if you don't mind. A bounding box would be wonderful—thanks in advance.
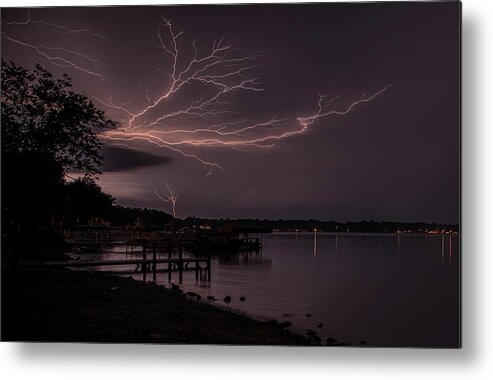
[1,60,113,262]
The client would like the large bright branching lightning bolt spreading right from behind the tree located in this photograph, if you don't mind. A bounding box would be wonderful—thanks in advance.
[94,17,392,175]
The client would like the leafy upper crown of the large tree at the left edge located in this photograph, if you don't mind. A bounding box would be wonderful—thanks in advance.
[1,60,113,177]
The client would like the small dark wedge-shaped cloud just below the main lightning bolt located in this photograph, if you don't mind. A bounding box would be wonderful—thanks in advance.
[102,146,172,172]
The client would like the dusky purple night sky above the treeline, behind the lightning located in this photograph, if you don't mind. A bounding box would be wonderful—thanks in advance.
[2,2,460,223]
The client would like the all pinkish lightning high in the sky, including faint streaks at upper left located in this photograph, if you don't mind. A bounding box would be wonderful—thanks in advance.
[2,11,392,175]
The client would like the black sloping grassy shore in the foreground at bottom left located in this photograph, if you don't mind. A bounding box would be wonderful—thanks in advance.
[1,270,309,345]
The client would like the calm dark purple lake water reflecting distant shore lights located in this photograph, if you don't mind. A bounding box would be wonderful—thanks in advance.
[75,233,460,347]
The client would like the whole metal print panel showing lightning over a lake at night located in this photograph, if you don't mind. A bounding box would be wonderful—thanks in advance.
[1,1,461,348]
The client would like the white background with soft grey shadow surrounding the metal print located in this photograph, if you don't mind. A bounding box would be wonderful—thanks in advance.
[0,0,493,380]
